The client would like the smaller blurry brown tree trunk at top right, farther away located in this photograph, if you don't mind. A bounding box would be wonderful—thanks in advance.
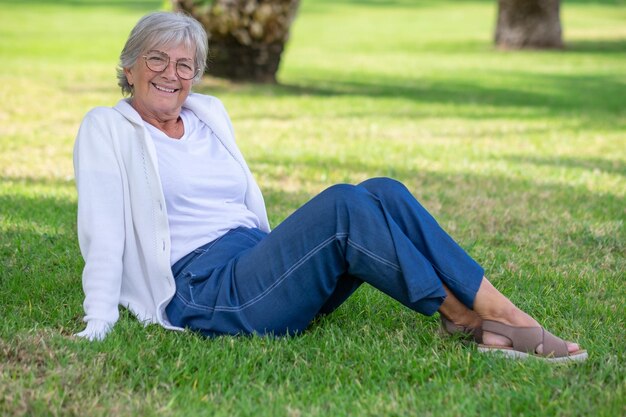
[495,0,563,49]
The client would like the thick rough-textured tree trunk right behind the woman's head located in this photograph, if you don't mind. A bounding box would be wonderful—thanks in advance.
[172,0,299,83]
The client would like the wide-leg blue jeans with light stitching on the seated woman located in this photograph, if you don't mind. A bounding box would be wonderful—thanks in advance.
[166,178,484,336]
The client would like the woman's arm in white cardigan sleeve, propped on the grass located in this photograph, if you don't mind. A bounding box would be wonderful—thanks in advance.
[74,108,125,340]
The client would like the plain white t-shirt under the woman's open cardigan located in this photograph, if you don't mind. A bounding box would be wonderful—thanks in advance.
[145,109,260,265]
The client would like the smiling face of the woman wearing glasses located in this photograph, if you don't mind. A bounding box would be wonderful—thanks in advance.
[124,45,194,121]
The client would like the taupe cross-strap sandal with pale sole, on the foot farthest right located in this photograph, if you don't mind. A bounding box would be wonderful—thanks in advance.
[478,320,587,362]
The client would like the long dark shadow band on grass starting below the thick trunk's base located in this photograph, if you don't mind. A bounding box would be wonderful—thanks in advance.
[198,71,626,122]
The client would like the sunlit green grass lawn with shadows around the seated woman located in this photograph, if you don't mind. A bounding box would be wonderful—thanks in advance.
[0,0,626,416]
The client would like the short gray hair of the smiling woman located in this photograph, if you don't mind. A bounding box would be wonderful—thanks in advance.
[117,12,209,96]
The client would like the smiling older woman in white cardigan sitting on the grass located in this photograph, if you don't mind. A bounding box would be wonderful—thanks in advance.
[74,13,586,361]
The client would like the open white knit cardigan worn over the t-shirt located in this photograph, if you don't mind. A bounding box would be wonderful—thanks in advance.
[74,94,269,339]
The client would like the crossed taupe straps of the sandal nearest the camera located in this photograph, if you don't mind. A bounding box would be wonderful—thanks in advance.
[483,320,569,358]
